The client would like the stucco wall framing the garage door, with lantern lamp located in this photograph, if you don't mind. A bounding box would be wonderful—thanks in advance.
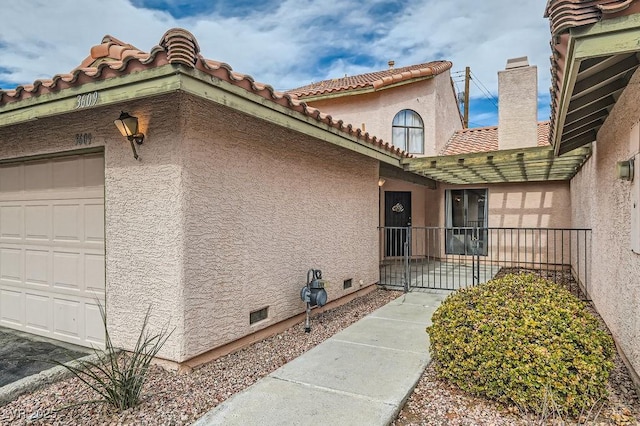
[0,98,189,358]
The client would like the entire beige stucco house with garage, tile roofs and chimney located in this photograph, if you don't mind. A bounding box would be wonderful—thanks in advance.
[0,0,640,390]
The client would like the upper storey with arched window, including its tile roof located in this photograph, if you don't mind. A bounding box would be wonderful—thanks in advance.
[287,61,462,157]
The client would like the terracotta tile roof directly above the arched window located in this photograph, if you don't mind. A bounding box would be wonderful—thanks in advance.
[286,61,453,98]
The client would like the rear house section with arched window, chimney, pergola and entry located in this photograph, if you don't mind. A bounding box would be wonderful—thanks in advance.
[287,58,590,263]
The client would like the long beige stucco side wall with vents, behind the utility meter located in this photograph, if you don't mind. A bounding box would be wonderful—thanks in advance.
[179,95,378,360]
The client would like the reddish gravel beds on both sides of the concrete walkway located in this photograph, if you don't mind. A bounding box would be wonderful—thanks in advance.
[0,280,640,426]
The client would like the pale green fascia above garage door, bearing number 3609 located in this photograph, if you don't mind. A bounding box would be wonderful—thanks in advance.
[0,65,180,127]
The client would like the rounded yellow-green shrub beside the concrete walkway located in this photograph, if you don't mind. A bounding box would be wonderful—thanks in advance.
[427,274,615,415]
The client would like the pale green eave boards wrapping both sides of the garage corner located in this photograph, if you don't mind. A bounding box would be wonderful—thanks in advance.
[0,64,402,167]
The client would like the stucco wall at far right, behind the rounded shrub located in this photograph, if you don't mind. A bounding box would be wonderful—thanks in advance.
[571,72,640,380]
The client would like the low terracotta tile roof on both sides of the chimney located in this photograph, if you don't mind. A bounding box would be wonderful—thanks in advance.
[441,121,549,155]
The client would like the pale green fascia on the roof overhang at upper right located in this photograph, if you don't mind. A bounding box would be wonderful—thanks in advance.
[551,14,640,155]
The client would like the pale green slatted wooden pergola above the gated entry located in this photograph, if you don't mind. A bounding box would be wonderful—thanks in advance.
[403,146,591,185]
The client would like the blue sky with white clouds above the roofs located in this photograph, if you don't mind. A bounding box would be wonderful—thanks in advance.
[0,0,550,127]
